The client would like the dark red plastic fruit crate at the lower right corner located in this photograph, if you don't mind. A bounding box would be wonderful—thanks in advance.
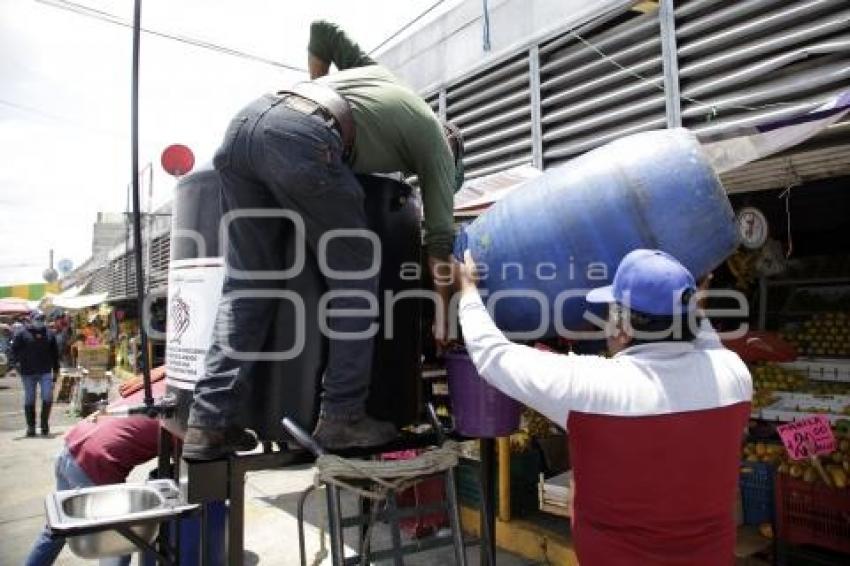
[776,474,850,553]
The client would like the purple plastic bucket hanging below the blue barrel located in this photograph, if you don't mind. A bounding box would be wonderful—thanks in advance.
[445,351,522,438]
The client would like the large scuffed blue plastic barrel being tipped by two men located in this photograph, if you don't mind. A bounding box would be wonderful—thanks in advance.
[455,129,738,337]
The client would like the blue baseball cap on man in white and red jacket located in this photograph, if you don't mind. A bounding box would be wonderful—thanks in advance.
[587,250,696,316]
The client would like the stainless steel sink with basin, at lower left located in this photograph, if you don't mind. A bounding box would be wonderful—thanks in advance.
[45,480,196,558]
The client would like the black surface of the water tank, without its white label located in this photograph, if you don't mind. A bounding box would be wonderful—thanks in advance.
[161,166,423,440]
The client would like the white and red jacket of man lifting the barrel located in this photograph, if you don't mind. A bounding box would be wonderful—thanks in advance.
[460,293,752,566]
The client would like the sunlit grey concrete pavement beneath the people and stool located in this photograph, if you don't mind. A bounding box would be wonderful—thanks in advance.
[0,375,535,566]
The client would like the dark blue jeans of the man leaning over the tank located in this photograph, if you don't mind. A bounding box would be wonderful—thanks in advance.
[189,95,380,428]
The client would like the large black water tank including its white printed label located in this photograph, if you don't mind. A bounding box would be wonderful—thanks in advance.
[166,166,422,440]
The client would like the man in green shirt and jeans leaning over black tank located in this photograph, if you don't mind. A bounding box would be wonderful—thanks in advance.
[183,23,459,460]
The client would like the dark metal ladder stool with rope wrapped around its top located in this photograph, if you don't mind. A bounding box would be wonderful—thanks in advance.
[283,406,466,566]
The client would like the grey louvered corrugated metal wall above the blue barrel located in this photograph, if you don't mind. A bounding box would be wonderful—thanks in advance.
[428,0,850,190]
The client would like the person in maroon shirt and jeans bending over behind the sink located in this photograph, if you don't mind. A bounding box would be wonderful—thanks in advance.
[25,380,165,566]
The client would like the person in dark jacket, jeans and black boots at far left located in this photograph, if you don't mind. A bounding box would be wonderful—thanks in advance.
[11,313,59,437]
